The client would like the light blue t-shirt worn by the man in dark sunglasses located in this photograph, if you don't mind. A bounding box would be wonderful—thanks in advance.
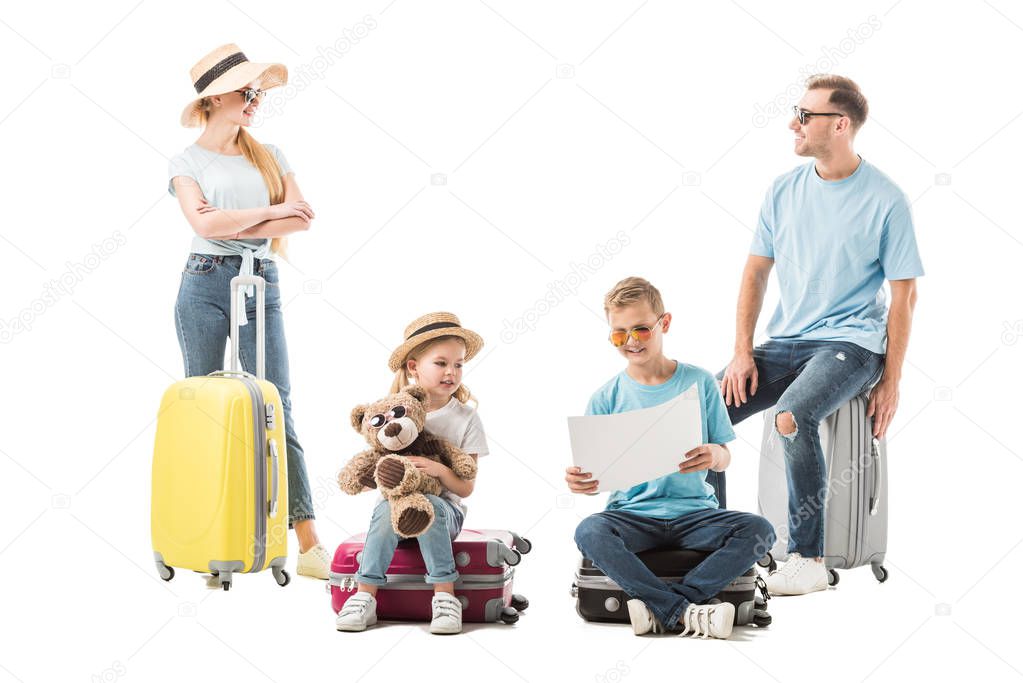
[750,157,924,354]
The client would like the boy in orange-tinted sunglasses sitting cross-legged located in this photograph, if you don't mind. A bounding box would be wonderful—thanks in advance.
[565,277,774,638]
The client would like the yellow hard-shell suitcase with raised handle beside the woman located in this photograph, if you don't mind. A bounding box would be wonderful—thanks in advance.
[150,276,290,590]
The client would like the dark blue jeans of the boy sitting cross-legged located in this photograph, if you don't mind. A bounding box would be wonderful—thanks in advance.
[575,509,774,630]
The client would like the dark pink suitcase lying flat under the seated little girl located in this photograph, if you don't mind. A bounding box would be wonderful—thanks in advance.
[330,529,532,624]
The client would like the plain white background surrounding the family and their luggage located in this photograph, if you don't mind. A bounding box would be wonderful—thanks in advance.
[0,0,1023,681]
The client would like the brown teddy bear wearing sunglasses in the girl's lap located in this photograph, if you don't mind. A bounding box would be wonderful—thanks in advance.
[338,384,476,538]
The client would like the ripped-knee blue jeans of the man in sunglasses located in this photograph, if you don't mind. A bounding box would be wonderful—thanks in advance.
[717,339,885,557]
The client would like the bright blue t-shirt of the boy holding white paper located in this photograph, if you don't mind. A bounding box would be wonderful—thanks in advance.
[586,361,736,519]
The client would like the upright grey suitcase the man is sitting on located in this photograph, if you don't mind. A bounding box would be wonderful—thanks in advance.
[758,395,888,586]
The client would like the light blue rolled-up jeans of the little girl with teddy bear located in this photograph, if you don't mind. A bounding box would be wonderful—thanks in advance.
[355,494,462,586]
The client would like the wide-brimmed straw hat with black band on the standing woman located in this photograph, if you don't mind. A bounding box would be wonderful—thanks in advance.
[181,43,287,128]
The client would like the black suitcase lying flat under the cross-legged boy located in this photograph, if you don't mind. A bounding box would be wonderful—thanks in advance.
[572,548,771,627]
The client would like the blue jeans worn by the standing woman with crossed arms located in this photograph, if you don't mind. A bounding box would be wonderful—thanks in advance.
[174,254,315,527]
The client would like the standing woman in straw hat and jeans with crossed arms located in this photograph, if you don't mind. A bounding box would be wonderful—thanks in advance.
[169,45,329,579]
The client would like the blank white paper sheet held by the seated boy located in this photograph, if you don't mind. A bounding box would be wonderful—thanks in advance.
[568,384,703,491]
